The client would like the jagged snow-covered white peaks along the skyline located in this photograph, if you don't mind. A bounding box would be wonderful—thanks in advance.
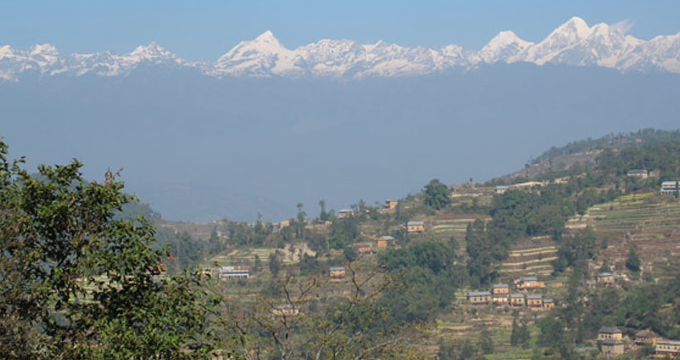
[0,17,680,81]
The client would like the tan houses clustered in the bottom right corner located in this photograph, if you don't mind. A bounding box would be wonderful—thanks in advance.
[597,326,680,358]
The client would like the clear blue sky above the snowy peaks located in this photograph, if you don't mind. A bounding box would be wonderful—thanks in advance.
[0,0,680,61]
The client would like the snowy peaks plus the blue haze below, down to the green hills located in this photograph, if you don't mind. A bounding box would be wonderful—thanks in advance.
[0,18,680,221]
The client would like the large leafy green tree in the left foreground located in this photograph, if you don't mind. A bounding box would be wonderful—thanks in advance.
[0,140,217,359]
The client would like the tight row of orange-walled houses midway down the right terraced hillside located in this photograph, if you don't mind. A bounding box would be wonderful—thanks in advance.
[467,276,555,311]
